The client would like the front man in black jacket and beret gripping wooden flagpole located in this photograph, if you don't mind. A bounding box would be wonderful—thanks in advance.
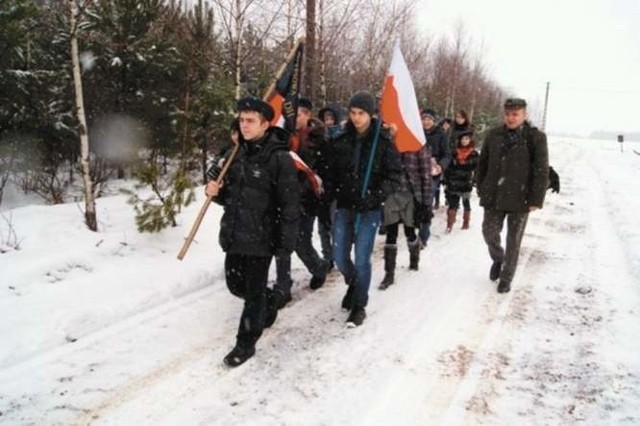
[205,97,300,367]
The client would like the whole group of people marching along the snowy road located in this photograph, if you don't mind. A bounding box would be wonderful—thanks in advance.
[205,92,548,366]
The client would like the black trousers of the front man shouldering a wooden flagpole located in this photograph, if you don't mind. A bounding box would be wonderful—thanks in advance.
[224,253,271,348]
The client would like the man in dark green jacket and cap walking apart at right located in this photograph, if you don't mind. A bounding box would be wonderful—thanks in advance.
[476,98,549,293]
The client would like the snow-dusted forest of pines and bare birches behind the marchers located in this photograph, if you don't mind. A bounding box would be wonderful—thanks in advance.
[0,0,507,232]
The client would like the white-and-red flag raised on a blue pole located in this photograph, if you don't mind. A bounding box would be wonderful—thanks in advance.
[380,43,427,152]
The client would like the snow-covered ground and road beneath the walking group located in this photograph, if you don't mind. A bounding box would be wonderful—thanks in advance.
[0,139,640,425]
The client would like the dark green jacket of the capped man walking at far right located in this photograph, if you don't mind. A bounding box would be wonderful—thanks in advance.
[476,123,549,212]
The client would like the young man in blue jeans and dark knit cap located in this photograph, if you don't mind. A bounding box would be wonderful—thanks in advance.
[320,92,403,326]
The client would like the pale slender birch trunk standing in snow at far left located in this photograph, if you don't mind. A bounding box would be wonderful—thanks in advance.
[68,0,98,231]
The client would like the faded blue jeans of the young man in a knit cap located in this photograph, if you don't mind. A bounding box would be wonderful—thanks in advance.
[333,209,381,308]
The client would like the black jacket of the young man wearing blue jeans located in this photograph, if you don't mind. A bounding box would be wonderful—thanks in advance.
[320,119,403,211]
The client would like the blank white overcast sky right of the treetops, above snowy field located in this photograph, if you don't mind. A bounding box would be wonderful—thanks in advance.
[417,0,640,135]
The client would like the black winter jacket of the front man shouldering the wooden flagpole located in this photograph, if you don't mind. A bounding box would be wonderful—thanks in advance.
[214,127,300,257]
